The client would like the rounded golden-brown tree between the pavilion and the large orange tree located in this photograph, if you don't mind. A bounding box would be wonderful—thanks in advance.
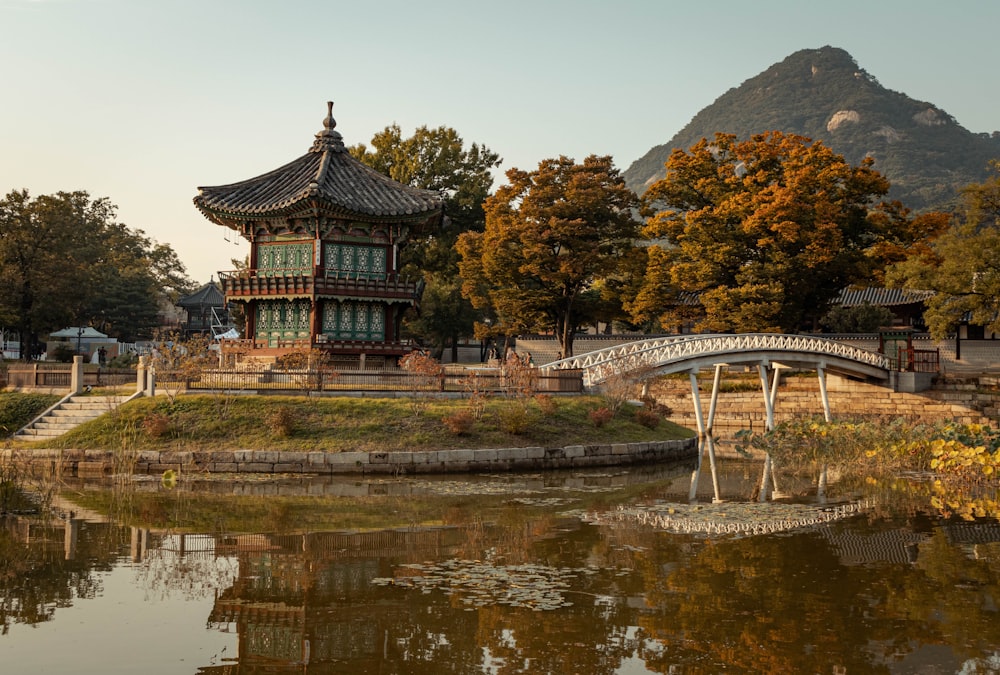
[457,155,638,357]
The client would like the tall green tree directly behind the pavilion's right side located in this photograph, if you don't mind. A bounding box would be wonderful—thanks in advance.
[350,124,501,360]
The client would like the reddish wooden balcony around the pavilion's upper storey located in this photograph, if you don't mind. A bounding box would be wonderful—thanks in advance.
[219,270,419,302]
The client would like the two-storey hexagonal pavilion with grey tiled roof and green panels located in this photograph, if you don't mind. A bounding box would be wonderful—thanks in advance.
[194,103,443,364]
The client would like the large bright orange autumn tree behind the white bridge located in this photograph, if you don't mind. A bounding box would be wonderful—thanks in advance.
[630,132,915,332]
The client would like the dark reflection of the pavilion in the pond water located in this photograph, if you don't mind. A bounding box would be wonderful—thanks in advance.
[209,527,486,673]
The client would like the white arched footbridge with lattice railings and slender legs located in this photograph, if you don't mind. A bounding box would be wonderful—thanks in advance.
[541,333,893,435]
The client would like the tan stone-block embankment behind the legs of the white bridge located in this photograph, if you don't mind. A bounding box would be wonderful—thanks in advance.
[651,374,1000,430]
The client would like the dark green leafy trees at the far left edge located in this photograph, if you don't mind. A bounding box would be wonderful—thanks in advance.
[0,190,190,358]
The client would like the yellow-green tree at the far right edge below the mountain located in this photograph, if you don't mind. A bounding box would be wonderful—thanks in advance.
[887,162,1000,339]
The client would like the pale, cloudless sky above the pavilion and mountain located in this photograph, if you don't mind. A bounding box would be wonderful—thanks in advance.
[0,0,1000,283]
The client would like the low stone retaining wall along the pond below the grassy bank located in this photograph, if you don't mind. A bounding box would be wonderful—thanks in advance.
[0,438,698,476]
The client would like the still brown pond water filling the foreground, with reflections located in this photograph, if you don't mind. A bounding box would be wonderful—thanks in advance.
[0,459,1000,675]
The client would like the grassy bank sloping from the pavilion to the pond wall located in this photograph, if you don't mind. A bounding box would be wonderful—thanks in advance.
[15,395,693,452]
